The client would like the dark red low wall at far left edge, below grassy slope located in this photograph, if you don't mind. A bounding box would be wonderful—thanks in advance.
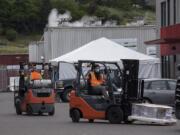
[0,54,29,65]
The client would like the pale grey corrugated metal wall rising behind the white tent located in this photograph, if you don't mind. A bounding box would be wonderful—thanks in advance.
[44,26,156,60]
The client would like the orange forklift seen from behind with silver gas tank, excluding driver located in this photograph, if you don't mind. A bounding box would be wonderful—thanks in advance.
[14,62,55,116]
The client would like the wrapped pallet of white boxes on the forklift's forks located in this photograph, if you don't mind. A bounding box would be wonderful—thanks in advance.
[129,103,176,124]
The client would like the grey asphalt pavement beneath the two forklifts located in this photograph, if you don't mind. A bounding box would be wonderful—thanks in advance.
[0,93,180,135]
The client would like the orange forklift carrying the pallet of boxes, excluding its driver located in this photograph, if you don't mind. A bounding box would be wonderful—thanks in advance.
[69,60,143,124]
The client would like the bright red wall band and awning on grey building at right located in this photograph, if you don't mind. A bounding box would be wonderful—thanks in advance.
[145,24,180,56]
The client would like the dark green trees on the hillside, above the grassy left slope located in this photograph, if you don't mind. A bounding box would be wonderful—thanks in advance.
[0,0,155,34]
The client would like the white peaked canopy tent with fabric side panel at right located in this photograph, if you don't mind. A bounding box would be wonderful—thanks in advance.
[50,38,160,78]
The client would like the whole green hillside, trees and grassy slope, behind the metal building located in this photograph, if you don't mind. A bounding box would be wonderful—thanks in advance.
[0,0,155,53]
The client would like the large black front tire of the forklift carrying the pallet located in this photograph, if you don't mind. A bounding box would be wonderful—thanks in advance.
[107,106,123,124]
